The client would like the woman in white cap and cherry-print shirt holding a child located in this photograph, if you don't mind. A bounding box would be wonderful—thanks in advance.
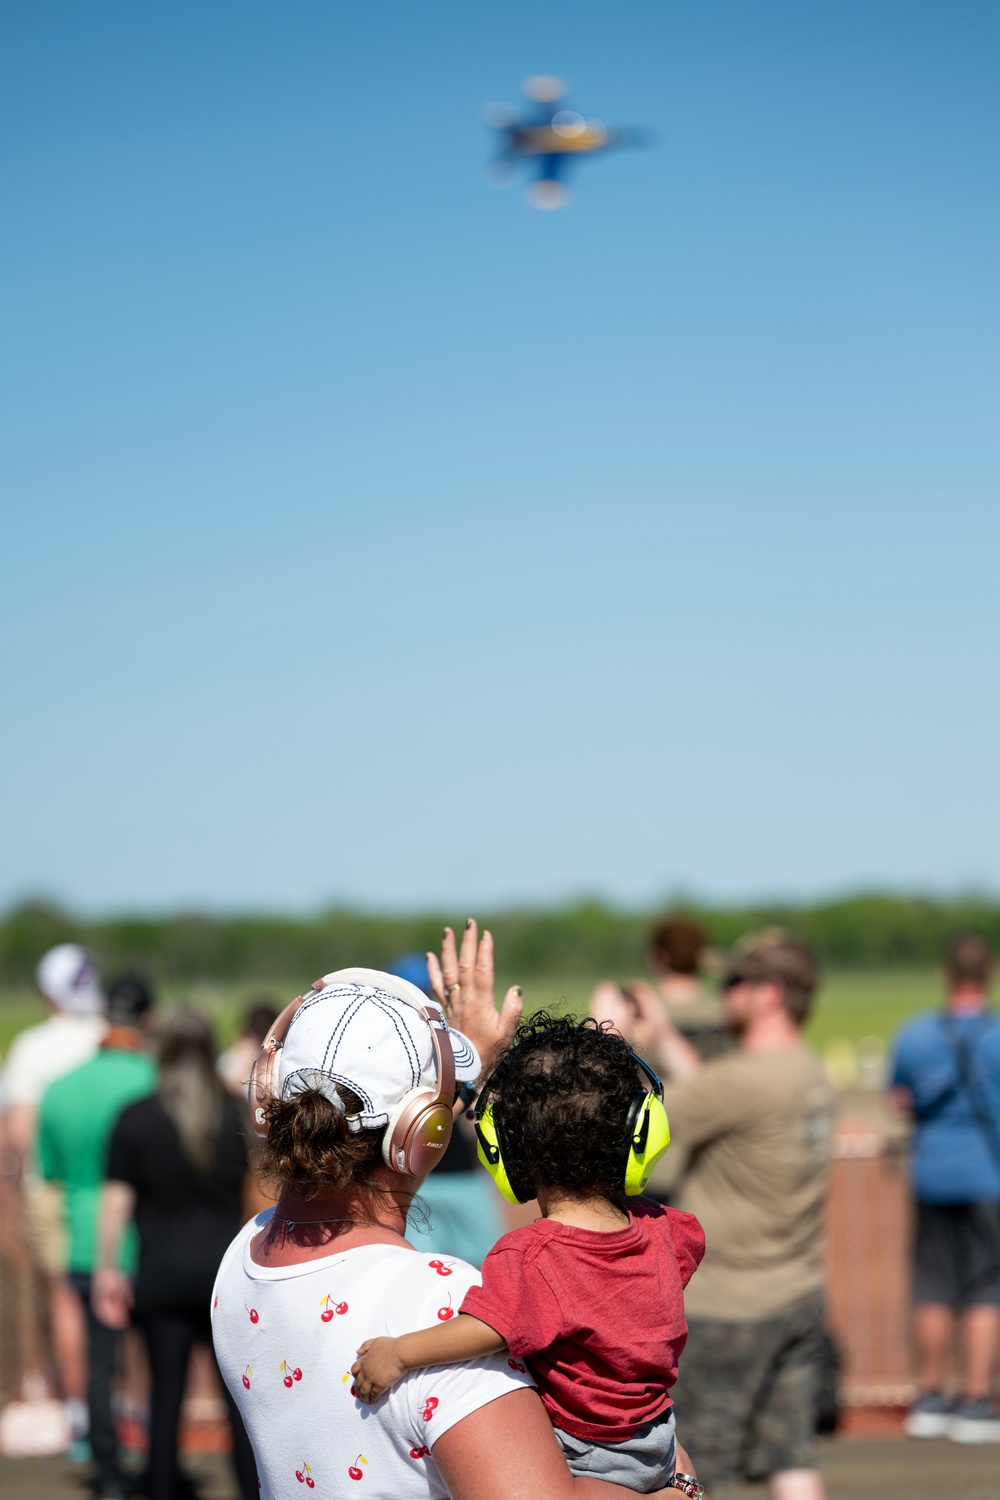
[211,963,675,1500]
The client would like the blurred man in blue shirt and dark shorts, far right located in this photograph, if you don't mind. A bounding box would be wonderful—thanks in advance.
[891,936,1000,1443]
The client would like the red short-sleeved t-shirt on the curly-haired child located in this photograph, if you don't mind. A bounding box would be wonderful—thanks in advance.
[462,1202,705,1443]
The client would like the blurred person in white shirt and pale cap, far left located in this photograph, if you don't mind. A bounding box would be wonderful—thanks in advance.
[3,942,106,1439]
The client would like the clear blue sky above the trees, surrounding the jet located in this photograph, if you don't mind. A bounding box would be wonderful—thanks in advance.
[0,0,1000,917]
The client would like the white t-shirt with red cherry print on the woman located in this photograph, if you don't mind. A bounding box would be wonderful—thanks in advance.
[211,1211,532,1500]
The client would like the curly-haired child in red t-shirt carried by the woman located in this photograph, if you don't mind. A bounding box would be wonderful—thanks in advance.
[351,1011,705,1494]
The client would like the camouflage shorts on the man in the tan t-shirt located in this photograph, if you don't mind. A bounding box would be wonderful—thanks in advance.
[673,1293,823,1485]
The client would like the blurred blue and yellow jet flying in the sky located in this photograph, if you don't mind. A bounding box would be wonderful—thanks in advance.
[483,74,640,209]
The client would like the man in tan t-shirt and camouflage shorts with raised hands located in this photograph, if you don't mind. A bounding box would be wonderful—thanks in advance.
[593,929,834,1500]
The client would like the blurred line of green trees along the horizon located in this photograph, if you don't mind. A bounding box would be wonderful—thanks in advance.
[0,894,1000,987]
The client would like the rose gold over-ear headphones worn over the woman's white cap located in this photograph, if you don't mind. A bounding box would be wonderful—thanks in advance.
[249,969,454,1178]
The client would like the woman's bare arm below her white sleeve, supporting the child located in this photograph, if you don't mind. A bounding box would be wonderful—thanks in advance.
[432,1389,678,1500]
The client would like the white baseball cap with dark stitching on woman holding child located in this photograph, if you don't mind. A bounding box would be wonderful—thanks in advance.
[276,969,481,1130]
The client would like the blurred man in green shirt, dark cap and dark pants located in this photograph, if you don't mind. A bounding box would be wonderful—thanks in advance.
[37,975,156,1500]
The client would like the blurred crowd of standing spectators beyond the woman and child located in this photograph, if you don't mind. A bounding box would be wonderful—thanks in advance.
[0,917,1000,1500]
